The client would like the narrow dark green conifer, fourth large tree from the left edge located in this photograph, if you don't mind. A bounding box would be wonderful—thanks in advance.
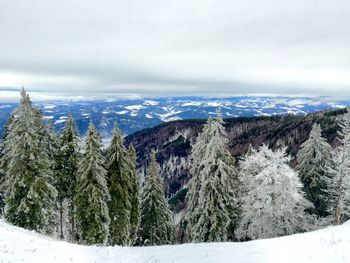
[107,127,131,245]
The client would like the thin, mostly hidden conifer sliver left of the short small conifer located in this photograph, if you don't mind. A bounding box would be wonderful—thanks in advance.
[127,144,140,244]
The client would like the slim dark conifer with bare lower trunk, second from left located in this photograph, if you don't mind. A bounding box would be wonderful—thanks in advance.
[56,113,80,241]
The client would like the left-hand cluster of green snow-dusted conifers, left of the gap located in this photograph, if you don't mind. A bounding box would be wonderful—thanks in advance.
[0,89,175,246]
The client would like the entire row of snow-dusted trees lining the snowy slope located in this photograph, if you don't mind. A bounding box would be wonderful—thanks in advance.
[0,89,350,246]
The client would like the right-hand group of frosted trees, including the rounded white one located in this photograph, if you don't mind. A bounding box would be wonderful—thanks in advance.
[183,110,350,242]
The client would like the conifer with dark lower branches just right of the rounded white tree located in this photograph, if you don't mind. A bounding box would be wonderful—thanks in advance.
[296,124,332,217]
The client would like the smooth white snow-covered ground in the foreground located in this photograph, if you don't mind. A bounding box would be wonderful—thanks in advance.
[0,221,350,263]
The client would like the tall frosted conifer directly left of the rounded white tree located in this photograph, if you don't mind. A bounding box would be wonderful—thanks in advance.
[186,113,239,242]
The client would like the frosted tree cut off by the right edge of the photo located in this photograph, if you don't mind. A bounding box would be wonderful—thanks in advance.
[327,109,350,224]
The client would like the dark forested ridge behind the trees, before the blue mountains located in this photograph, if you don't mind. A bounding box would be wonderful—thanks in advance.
[126,109,345,203]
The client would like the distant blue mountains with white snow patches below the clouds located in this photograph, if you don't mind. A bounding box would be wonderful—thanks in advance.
[0,96,350,137]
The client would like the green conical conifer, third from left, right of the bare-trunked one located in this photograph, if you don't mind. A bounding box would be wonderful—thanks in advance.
[74,122,110,245]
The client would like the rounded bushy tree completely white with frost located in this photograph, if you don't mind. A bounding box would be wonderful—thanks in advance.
[237,145,312,240]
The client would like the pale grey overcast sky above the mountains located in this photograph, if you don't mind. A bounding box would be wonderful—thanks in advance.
[0,0,350,100]
